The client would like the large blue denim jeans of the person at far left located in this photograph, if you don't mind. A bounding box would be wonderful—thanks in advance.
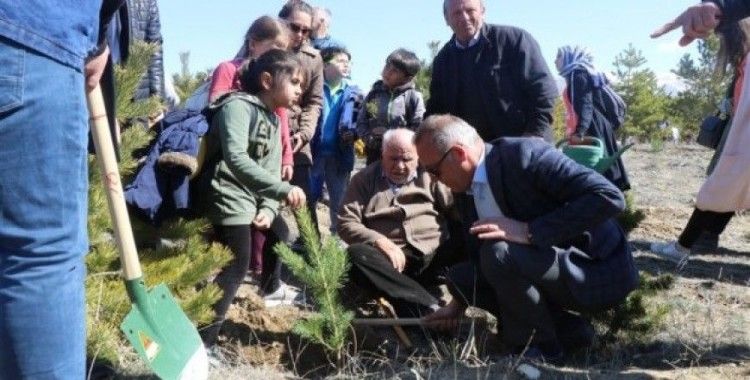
[0,38,88,379]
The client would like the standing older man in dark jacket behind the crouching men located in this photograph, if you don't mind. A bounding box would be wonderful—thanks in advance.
[427,0,558,141]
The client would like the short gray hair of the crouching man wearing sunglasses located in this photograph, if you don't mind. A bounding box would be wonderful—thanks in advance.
[414,114,481,154]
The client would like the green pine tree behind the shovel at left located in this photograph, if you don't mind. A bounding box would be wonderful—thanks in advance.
[86,43,230,366]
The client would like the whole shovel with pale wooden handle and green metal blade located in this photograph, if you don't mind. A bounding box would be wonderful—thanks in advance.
[87,85,208,380]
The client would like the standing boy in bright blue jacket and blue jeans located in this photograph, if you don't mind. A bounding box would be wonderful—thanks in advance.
[310,46,362,234]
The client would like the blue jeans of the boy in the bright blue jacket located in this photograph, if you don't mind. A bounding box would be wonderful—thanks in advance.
[310,156,351,233]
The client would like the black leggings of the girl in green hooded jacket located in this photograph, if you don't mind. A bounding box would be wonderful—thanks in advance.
[201,225,251,347]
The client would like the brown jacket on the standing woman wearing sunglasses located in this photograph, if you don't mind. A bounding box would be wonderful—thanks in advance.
[289,43,323,165]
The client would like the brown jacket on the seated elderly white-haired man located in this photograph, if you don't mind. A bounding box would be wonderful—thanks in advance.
[338,161,458,255]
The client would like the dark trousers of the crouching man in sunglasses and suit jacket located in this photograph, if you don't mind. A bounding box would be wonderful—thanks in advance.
[448,241,587,348]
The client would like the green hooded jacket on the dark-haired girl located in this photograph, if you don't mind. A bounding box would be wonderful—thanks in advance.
[199,92,292,225]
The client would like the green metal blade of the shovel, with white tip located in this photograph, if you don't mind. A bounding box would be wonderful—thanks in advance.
[120,278,208,380]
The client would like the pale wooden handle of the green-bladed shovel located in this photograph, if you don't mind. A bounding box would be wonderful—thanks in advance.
[86,85,143,280]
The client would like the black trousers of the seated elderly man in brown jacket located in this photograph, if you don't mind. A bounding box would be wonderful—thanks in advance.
[347,240,461,314]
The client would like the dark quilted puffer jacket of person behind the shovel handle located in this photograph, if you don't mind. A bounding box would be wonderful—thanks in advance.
[113,0,164,100]
